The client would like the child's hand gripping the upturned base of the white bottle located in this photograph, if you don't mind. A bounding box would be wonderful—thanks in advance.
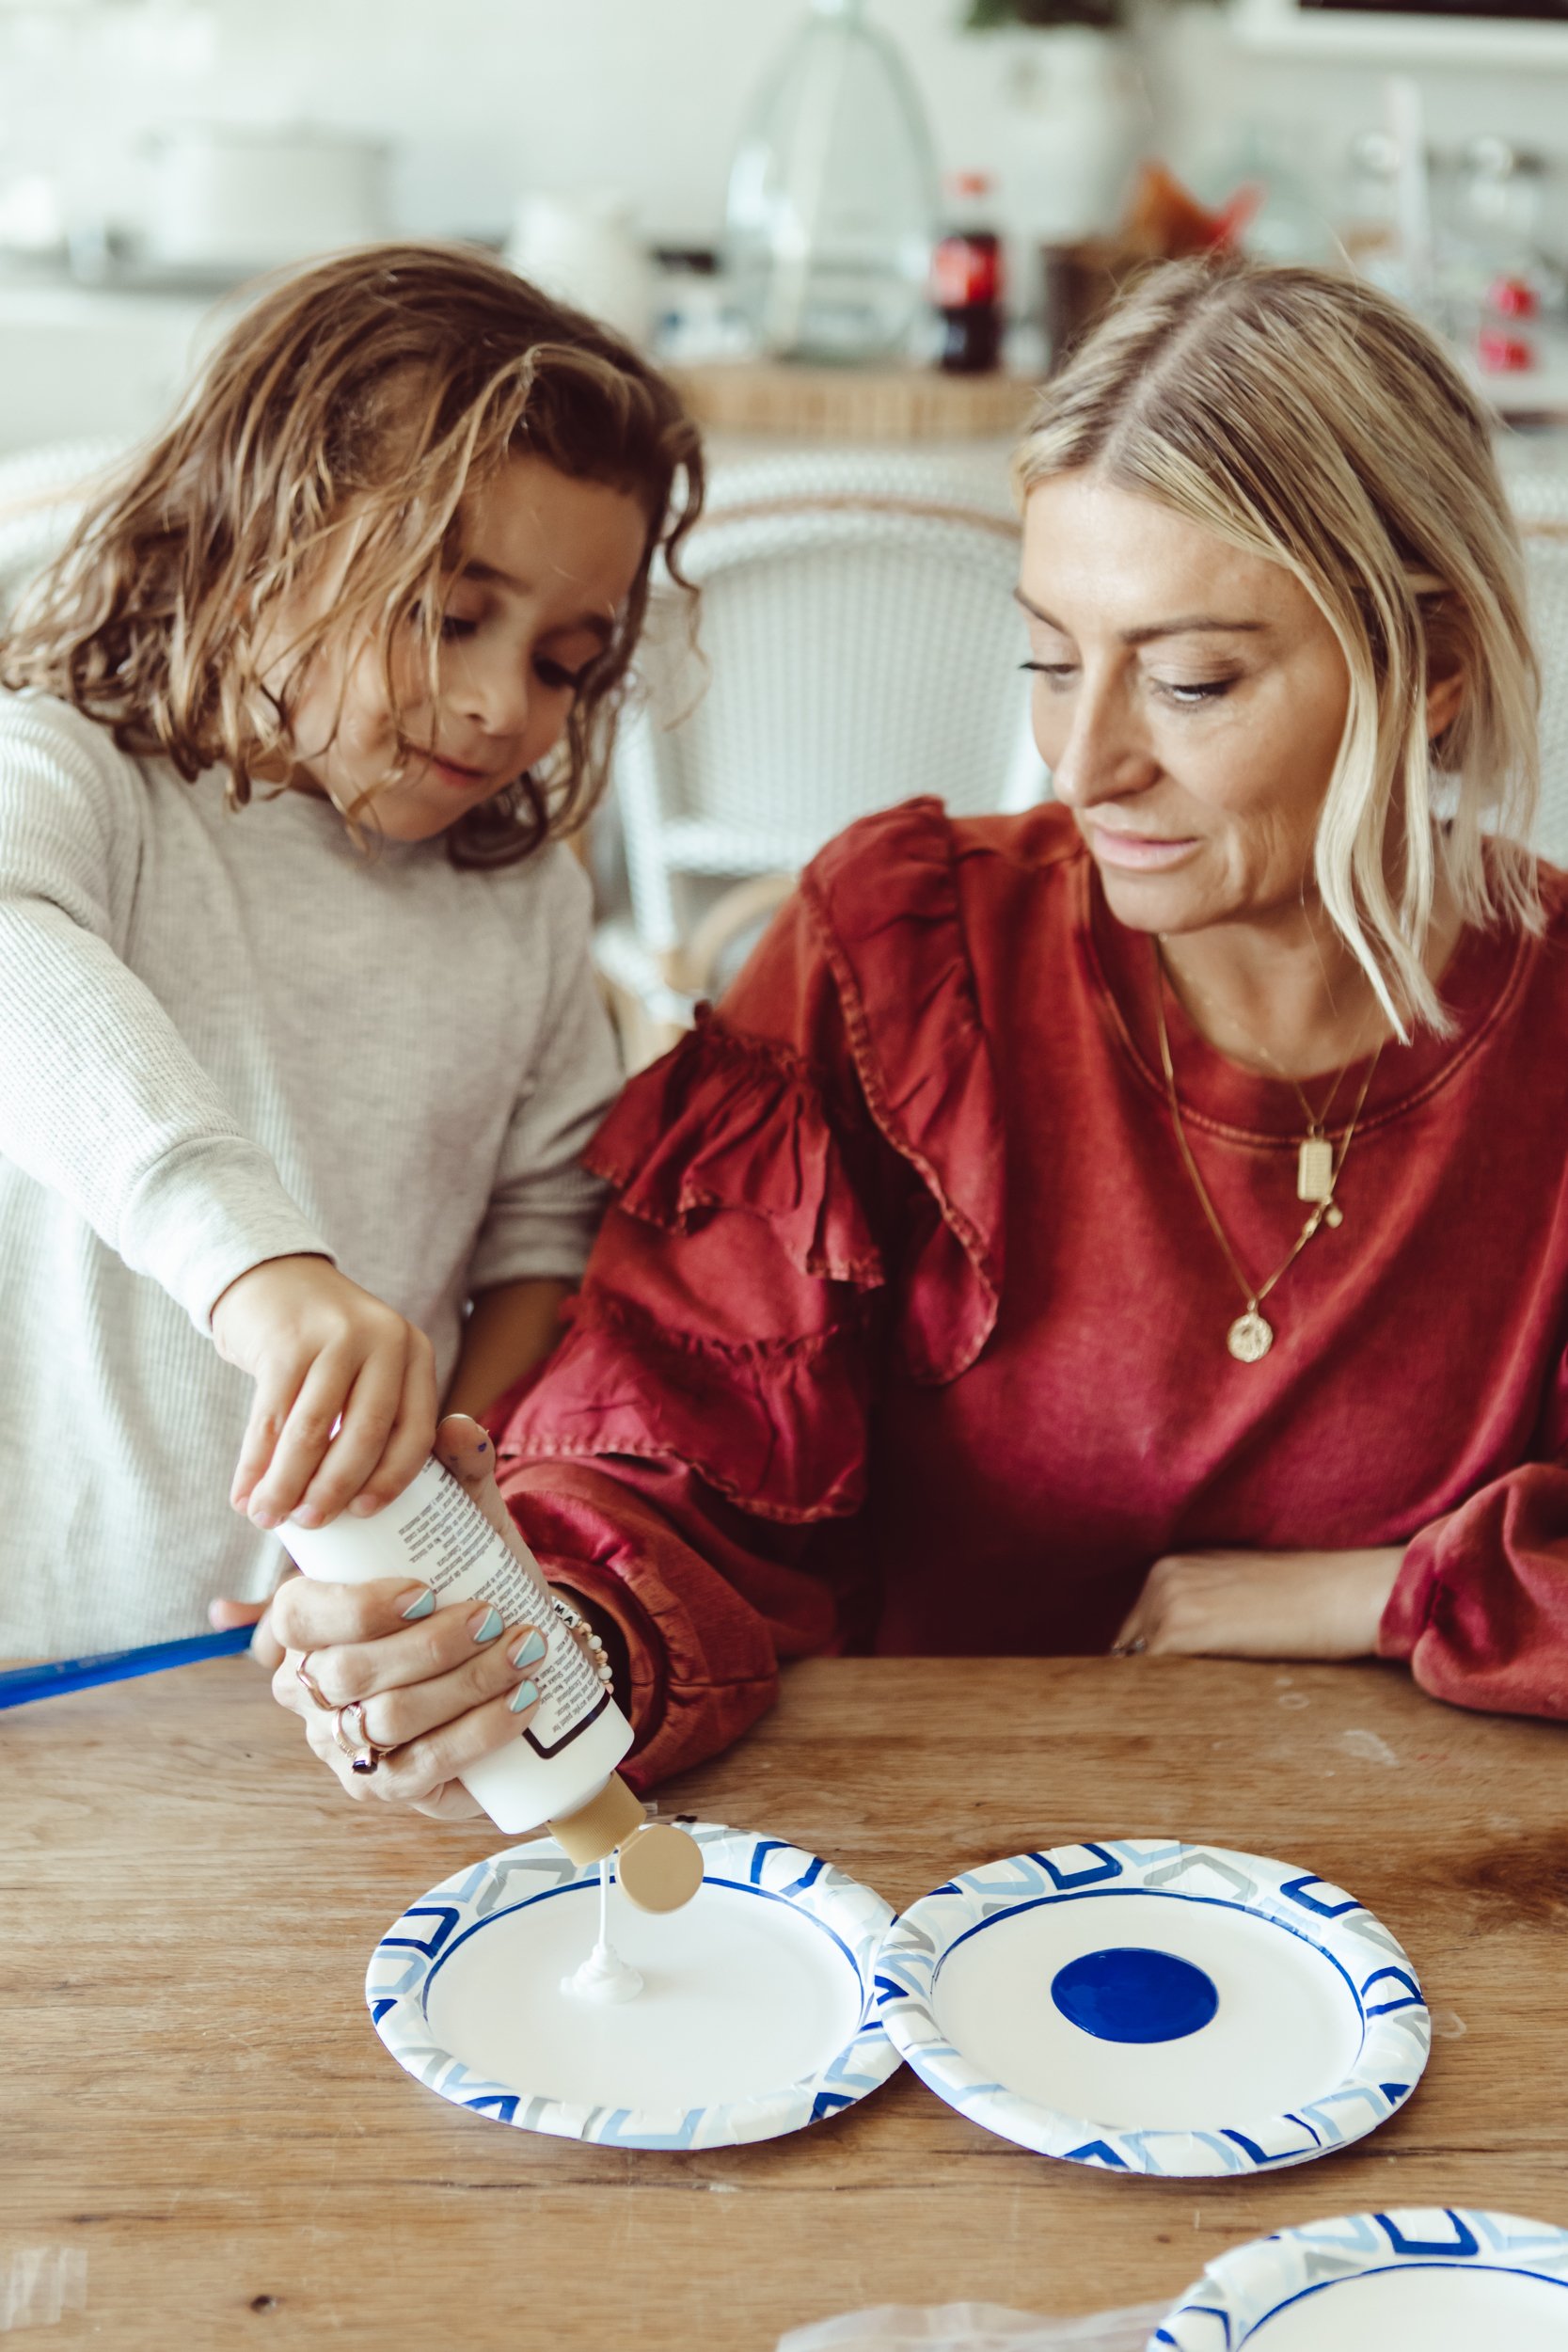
[212,1256,437,1527]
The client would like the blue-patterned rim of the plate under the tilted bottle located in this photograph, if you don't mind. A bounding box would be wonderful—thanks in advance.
[364,1820,898,2148]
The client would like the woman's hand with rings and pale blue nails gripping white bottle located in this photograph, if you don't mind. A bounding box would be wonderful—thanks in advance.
[251,1414,594,1820]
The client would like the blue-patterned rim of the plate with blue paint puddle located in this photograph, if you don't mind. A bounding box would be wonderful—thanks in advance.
[877,1837,1432,2181]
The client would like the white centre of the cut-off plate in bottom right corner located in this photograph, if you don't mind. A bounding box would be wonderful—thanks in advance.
[1246,2263,1568,2352]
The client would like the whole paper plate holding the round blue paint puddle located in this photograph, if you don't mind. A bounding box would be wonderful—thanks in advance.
[877,1839,1432,2178]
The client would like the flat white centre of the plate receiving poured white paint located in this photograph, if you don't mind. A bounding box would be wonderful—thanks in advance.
[425,1880,863,2107]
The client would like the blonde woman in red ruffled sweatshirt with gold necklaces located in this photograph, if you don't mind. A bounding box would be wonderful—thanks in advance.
[262,266,1568,1806]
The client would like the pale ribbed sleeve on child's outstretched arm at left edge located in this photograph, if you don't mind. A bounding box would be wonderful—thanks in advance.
[0,696,331,1331]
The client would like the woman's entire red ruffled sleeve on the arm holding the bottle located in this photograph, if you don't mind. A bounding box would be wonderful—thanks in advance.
[496,803,1004,1786]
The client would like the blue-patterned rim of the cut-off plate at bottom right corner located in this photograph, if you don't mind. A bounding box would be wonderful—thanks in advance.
[1149,2206,1568,2352]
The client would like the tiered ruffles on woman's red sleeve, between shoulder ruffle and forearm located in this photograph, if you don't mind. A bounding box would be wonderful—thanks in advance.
[499,997,884,1524]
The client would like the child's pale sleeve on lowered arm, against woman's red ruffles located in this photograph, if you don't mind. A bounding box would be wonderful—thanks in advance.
[467,850,621,1292]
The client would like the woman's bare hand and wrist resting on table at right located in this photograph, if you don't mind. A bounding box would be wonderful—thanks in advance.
[1112,1546,1403,1659]
